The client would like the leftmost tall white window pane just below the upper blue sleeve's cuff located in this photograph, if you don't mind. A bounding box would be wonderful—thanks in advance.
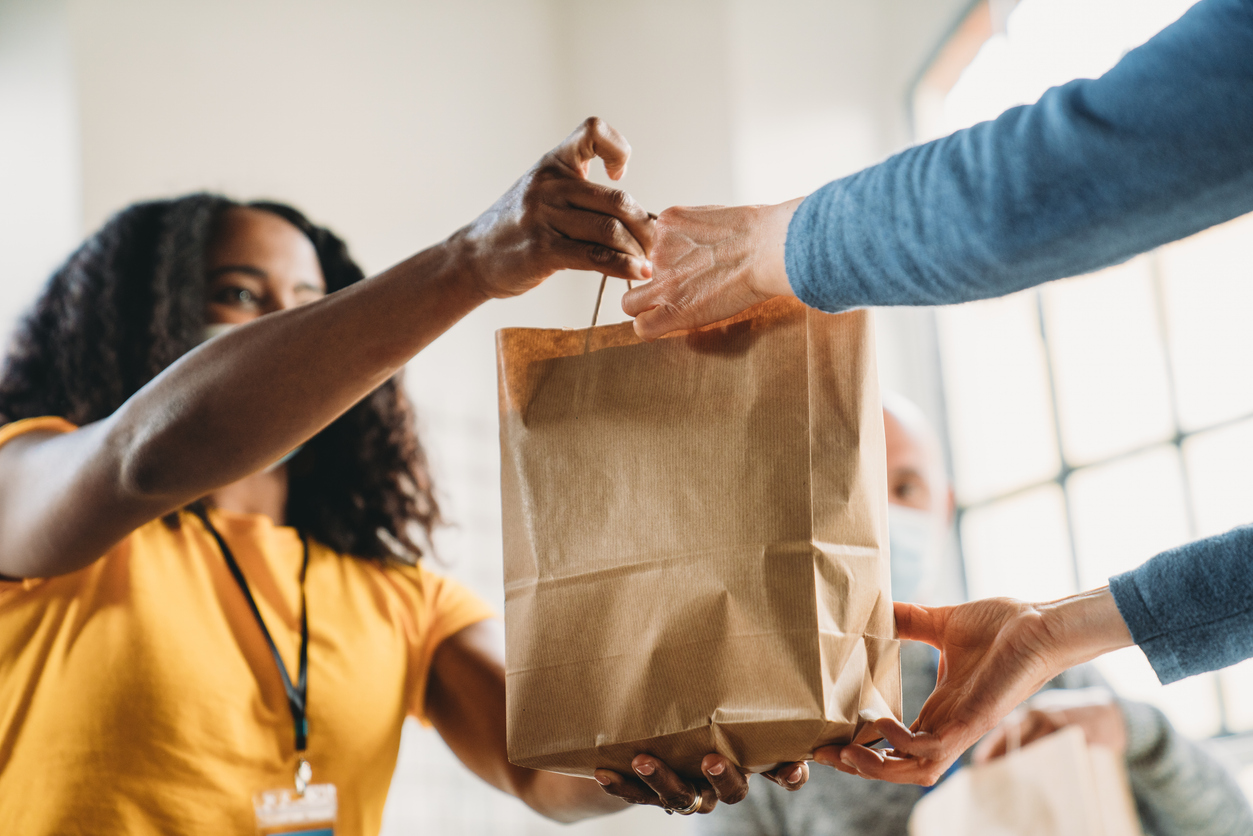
[937,292,1060,504]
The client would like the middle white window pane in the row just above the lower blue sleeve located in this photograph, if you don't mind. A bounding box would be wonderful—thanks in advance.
[1066,445,1188,589]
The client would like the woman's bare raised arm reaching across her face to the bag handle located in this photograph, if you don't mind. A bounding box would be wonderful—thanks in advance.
[0,119,653,578]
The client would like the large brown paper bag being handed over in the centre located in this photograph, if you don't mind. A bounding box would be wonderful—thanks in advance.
[496,298,901,776]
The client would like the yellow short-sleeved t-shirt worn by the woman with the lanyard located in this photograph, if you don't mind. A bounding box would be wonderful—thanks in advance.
[0,419,491,836]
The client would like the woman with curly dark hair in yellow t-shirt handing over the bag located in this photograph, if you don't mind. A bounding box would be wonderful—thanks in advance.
[0,119,801,836]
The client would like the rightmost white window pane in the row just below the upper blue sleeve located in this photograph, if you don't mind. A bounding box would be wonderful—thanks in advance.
[1158,216,1253,429]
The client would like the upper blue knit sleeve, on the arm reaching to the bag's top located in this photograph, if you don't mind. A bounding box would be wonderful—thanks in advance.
[786,0,1253,311]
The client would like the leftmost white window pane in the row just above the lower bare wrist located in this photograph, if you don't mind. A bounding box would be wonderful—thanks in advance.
[961,485,1075,600]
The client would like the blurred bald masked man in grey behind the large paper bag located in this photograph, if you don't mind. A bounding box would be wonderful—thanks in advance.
[697,392,1253,836]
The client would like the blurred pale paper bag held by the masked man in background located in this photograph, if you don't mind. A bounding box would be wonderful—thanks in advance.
[910,726,1143,836]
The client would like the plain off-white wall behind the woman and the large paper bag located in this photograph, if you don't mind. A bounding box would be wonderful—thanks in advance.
[0,0,966,833]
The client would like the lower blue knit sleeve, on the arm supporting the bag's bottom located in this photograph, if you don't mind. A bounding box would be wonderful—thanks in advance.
[1109,526,1253,683]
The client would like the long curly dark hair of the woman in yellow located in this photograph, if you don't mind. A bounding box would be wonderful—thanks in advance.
[0,194,440,562]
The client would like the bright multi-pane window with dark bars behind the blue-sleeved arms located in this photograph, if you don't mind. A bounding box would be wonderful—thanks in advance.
[913,0,1253,737]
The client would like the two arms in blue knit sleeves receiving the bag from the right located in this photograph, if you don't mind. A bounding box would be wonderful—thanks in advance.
[623,0,1253,783]
